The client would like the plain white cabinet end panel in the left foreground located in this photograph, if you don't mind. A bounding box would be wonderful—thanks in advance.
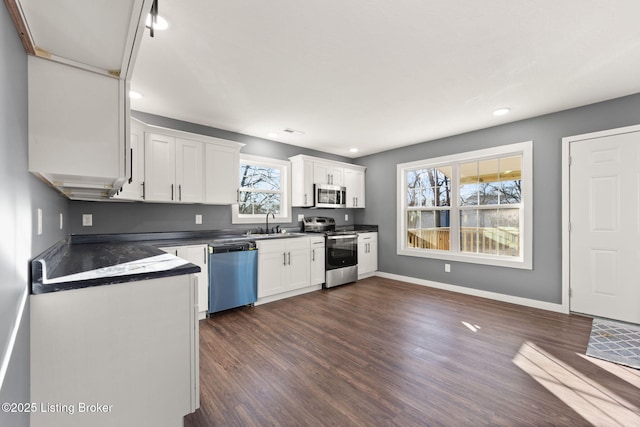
[30,274,200,427]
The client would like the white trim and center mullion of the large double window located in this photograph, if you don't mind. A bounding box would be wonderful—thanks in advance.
[396,141,533,270]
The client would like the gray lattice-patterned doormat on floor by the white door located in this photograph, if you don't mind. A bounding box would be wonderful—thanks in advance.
[587,318,640,369]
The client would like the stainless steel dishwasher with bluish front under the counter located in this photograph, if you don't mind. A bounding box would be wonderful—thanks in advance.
[209,242,258,313]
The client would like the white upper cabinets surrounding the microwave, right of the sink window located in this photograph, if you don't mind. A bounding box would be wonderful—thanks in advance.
[289,154,366,208]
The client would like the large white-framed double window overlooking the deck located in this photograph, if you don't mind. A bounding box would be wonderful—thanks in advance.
[397,141,533,269]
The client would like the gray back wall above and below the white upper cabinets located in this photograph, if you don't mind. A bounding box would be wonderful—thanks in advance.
[70,111,356,234]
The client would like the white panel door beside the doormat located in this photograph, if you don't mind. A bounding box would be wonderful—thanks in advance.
[570,132,640,323]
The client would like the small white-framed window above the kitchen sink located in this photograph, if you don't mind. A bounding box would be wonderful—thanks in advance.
[232,155,291,224]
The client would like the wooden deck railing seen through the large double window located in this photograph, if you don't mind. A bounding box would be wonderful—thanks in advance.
[407,227,520,257]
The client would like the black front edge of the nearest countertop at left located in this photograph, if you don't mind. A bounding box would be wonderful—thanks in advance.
[31,263,200,295]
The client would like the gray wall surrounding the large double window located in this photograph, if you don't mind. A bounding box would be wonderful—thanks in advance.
[356,94,640,304]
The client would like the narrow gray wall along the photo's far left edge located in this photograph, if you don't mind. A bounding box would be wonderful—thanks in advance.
[0,6,68,426]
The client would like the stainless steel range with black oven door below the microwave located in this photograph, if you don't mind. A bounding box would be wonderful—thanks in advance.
[303,216,358,288]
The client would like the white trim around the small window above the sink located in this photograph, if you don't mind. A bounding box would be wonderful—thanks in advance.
[231,154,291,224]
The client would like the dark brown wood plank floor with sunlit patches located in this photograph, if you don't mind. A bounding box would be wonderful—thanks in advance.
[185,277,640,426]
